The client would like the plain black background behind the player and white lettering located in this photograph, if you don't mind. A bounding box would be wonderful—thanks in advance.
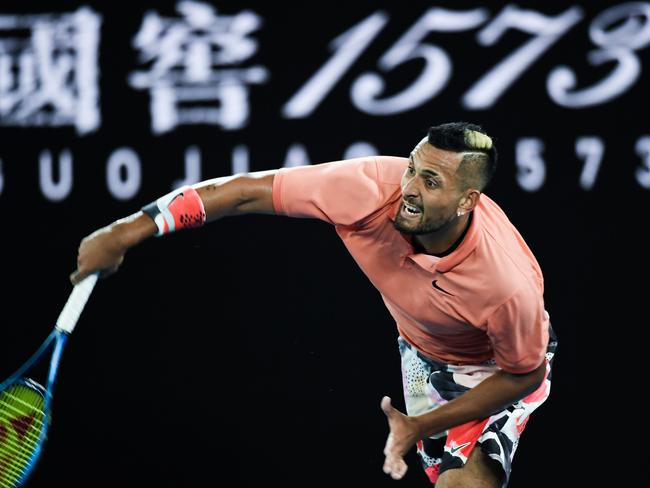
[0,1,649,488]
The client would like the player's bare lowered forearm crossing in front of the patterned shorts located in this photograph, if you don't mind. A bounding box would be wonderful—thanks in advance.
[413,362,546,438]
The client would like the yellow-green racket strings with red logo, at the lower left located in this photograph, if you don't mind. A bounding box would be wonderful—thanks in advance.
[0,383,46,488]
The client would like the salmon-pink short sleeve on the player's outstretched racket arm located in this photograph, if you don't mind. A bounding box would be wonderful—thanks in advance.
[273,157,382,225]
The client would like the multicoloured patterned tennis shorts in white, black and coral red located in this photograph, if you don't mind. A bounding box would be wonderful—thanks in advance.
[398,328,557,487]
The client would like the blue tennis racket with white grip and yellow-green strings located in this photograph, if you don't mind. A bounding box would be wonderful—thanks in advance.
[0,274,97,488]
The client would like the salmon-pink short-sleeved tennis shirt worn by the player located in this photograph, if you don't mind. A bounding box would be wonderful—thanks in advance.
[273,156,549,373]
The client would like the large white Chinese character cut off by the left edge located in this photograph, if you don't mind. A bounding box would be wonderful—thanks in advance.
[0,7,102,134]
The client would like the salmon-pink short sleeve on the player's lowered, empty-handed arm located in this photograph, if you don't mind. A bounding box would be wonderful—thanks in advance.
[487,287,549,374]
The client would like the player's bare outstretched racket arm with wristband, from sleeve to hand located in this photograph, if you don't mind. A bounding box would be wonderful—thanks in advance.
[70,170,277,284]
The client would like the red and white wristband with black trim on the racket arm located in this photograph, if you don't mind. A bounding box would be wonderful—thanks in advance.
[142,186,205,236]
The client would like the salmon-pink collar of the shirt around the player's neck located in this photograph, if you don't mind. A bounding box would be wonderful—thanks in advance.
[389,199,482,273]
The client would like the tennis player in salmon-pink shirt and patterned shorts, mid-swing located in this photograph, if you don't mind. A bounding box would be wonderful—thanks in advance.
[71,122,557,488]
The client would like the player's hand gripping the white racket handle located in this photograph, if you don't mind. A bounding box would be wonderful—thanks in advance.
[70,225,127,285]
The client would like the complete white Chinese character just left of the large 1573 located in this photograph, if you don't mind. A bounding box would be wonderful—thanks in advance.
[129,1,269,134]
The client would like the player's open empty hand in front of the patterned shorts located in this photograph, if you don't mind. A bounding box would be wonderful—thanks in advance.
[381,397,420,480]
